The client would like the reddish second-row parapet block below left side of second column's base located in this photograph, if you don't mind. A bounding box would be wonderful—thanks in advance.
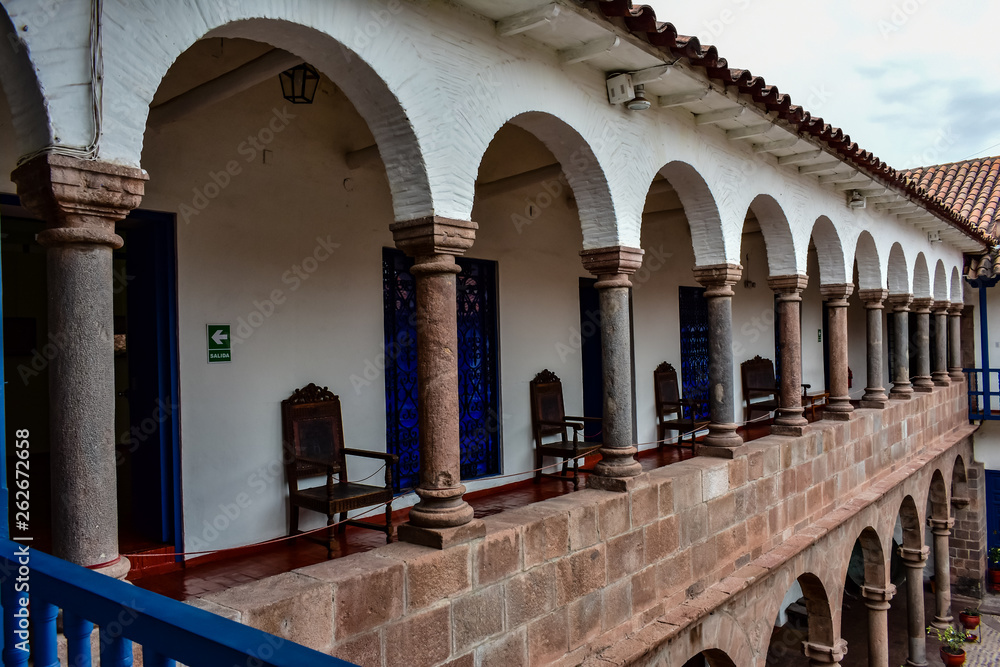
[385,604,451,667]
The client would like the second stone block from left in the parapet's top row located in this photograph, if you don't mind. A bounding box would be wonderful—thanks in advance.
[298,553,405,642]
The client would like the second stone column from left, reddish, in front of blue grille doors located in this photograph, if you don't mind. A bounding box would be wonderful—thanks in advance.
[389,216,485,548]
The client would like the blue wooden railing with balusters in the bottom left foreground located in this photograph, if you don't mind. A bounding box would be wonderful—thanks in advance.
[0,539,351,667]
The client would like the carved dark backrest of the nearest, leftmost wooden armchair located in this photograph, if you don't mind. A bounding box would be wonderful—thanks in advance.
[281,383,346,490]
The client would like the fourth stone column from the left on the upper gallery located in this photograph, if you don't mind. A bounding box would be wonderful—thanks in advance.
[694,264,745,458]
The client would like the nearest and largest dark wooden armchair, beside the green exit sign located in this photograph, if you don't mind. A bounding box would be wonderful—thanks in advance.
[281,383,399,556]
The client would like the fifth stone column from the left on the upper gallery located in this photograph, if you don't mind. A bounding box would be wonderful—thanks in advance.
[767,274,809,435]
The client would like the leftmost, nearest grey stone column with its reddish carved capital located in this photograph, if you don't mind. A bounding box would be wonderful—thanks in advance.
[11,154,147,578]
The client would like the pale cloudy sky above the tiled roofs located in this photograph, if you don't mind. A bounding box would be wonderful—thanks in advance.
[633,0,1000,169]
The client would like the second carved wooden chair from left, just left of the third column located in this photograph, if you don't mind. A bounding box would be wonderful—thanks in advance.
[530,369,601,490]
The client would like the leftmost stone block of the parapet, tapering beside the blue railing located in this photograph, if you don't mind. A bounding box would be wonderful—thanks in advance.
[204,572,333,651]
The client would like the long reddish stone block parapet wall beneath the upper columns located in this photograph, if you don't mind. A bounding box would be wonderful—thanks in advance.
[200,385,973,667]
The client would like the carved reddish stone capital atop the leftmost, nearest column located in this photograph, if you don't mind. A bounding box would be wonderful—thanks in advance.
[11,153,149,248]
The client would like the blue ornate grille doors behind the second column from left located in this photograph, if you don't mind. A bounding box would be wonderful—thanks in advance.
[382,248,500,492]
